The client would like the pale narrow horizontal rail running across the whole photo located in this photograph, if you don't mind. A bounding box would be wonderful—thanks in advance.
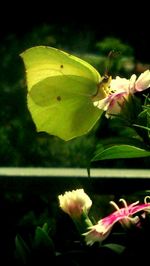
[0,167,150,179]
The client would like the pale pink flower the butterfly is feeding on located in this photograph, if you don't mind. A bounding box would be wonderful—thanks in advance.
[94,70,150,117]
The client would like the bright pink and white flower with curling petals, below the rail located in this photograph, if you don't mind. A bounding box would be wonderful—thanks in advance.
[83,197,150,245]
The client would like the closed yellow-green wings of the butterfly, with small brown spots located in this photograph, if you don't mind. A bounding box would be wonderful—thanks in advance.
[22,46,102,140]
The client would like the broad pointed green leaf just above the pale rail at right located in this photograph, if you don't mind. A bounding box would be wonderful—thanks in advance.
[92,145,150,161]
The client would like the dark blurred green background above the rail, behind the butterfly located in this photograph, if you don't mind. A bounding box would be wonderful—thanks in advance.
[0,1,150,168]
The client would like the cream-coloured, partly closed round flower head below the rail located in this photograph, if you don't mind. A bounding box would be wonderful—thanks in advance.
[58,189,92,218]
